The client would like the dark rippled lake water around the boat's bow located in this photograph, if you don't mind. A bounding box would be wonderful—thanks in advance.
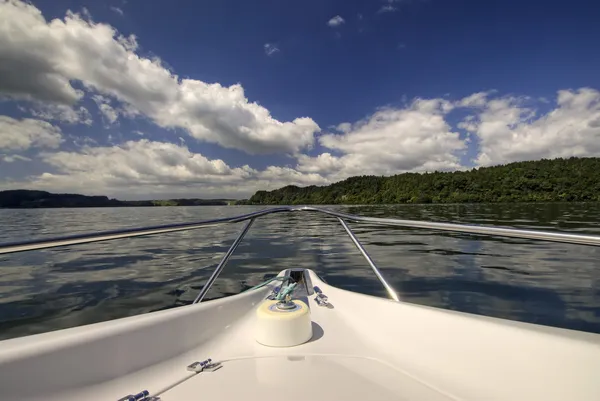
[0,204,600,339]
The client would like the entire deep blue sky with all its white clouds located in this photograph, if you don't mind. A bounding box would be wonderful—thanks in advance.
[0,0,600,199]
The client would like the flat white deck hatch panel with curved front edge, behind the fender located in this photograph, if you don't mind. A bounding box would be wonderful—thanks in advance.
[160,355,452,401]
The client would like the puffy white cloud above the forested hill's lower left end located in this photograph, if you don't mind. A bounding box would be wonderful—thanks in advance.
[297,99,466,181]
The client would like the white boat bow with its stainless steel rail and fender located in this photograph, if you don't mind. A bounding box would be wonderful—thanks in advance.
[0,207,600,401]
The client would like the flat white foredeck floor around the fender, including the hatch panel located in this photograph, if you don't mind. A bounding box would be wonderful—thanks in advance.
[160,290,452,401]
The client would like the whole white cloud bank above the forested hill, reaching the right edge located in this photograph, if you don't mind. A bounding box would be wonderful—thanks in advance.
[296,88,600,181]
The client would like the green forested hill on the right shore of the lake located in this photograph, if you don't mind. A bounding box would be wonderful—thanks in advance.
[246,157,600,205]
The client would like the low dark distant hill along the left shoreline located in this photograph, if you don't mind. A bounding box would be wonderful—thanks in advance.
[0,189,236,209]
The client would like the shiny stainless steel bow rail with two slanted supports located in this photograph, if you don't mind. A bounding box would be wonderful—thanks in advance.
[0,206,600,303]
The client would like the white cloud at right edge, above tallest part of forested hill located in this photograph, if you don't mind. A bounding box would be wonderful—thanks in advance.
[461,88,600,165]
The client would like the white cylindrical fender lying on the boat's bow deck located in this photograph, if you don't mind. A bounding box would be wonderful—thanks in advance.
[255,299,312,347]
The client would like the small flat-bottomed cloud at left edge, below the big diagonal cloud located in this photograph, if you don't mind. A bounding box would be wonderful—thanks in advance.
[0,116,63,150]
